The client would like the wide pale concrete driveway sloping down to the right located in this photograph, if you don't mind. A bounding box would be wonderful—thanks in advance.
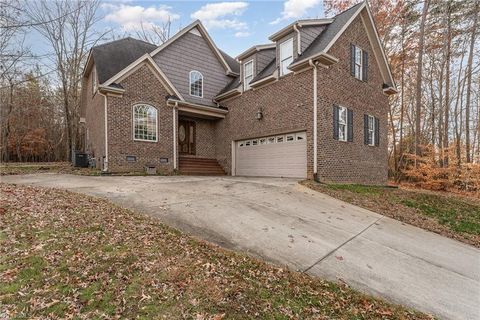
[1,174,480,319]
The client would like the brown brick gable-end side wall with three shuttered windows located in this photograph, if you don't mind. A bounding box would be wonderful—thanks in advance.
[318,17,388,184]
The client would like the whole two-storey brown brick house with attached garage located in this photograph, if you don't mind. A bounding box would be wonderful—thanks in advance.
[81,2,396,184]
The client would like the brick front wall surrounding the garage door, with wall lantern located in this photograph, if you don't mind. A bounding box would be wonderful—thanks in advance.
[215,70,313,177]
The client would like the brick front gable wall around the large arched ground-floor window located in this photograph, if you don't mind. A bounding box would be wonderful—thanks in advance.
[108,65,173,173]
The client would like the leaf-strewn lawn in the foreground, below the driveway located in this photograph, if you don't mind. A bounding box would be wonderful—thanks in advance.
[0,183,430,319]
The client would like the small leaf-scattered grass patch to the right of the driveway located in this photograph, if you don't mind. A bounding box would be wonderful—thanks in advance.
[302,181,480,248]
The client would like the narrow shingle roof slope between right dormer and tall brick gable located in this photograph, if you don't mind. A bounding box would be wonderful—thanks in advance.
[293,2,364,63]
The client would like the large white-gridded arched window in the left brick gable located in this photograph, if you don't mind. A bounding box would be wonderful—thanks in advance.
[133,103,158,142]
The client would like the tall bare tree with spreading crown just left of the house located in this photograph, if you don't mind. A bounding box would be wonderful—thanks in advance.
[27,0,101,158]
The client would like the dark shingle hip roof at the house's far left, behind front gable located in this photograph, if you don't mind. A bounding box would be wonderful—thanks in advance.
[92,37,157,83]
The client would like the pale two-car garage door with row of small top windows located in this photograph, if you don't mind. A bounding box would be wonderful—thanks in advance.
[235,132,307,178]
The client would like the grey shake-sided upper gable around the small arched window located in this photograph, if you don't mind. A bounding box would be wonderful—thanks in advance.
[153,32,232,106]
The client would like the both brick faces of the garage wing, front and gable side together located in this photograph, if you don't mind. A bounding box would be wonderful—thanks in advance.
[216,18,388,184]
